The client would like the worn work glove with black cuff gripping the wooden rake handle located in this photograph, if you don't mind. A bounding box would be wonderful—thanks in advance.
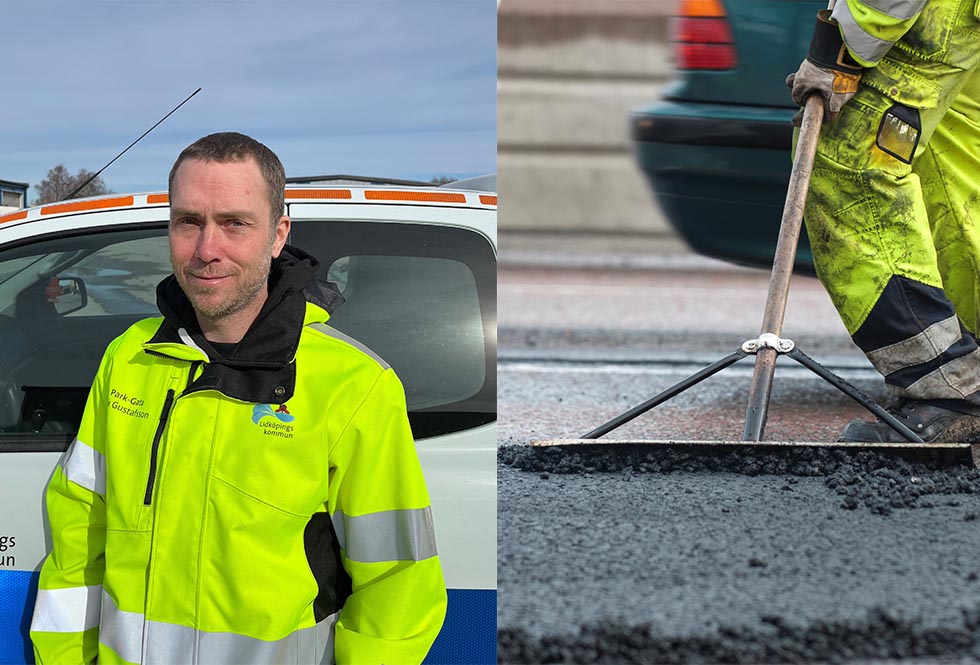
[786,9,864,127]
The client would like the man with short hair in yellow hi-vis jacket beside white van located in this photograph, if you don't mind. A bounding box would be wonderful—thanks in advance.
[31,133,446,665]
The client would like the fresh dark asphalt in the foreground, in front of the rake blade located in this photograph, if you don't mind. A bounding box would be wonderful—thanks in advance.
[498,446,980,663]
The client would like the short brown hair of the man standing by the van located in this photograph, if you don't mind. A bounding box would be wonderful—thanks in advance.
[167,132,286,222]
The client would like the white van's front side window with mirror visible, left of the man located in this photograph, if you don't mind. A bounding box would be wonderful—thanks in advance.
[0,224,170,442]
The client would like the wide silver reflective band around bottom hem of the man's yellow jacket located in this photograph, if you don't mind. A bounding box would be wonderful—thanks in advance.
[99,594,338,665]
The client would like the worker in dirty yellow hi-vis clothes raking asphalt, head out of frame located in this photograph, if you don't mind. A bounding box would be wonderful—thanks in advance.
[787,0,980,442]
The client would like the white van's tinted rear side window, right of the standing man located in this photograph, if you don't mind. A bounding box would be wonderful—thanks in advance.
[290,220,497,439]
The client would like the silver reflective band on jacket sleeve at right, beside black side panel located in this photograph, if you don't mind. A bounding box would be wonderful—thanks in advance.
[331,507,438,563]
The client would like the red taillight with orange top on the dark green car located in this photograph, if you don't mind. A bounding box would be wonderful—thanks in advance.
[671,0,737,70]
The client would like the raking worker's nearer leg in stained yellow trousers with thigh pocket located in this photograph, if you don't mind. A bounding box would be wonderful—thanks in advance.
[805,0,980,404]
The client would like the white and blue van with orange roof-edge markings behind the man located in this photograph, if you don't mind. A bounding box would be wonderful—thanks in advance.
[0,186,497,663]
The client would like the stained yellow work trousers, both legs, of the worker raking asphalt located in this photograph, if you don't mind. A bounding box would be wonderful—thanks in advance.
[804,0,980,404]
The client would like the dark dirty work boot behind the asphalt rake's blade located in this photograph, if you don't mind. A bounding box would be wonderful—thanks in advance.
[839,399,980,443]
